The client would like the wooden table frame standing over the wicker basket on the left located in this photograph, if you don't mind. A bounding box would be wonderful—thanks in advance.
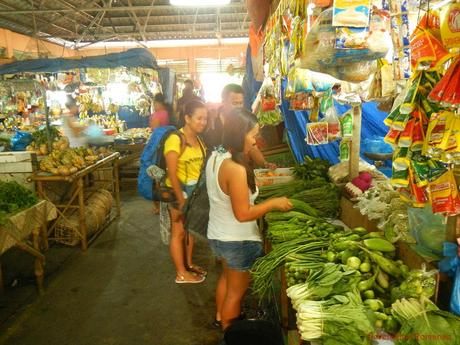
[31,152,121,250]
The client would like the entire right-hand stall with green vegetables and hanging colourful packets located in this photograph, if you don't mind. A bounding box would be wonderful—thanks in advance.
[248,0,460,344]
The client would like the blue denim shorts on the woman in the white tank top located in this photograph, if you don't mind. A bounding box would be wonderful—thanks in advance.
[208,240,264,271]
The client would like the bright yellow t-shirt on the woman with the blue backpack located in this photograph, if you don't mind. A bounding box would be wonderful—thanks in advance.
[164,130,204,187]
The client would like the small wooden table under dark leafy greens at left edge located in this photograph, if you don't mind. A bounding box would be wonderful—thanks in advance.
[0,200,57,293]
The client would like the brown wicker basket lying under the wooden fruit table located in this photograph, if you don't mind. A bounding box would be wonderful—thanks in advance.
[54,189,113,246]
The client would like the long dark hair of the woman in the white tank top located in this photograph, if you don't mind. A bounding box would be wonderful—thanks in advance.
[222,108,257,193]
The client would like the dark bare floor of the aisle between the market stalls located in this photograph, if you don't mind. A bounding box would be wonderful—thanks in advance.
[0,195,221,345]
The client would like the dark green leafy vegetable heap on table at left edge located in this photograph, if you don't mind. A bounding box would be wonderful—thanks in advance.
[0,181,38,225]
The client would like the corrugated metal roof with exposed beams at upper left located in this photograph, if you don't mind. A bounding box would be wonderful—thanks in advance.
[0,0,249,43]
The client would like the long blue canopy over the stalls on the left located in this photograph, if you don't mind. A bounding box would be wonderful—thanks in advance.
[0,48,158,74]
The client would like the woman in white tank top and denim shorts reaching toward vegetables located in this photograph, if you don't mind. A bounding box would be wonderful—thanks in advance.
[206,108,292,329]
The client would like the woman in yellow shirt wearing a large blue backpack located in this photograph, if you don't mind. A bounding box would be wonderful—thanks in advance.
[164,101,208,284]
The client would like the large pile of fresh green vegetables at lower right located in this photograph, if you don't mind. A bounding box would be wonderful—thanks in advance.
[251,195,460,345]
